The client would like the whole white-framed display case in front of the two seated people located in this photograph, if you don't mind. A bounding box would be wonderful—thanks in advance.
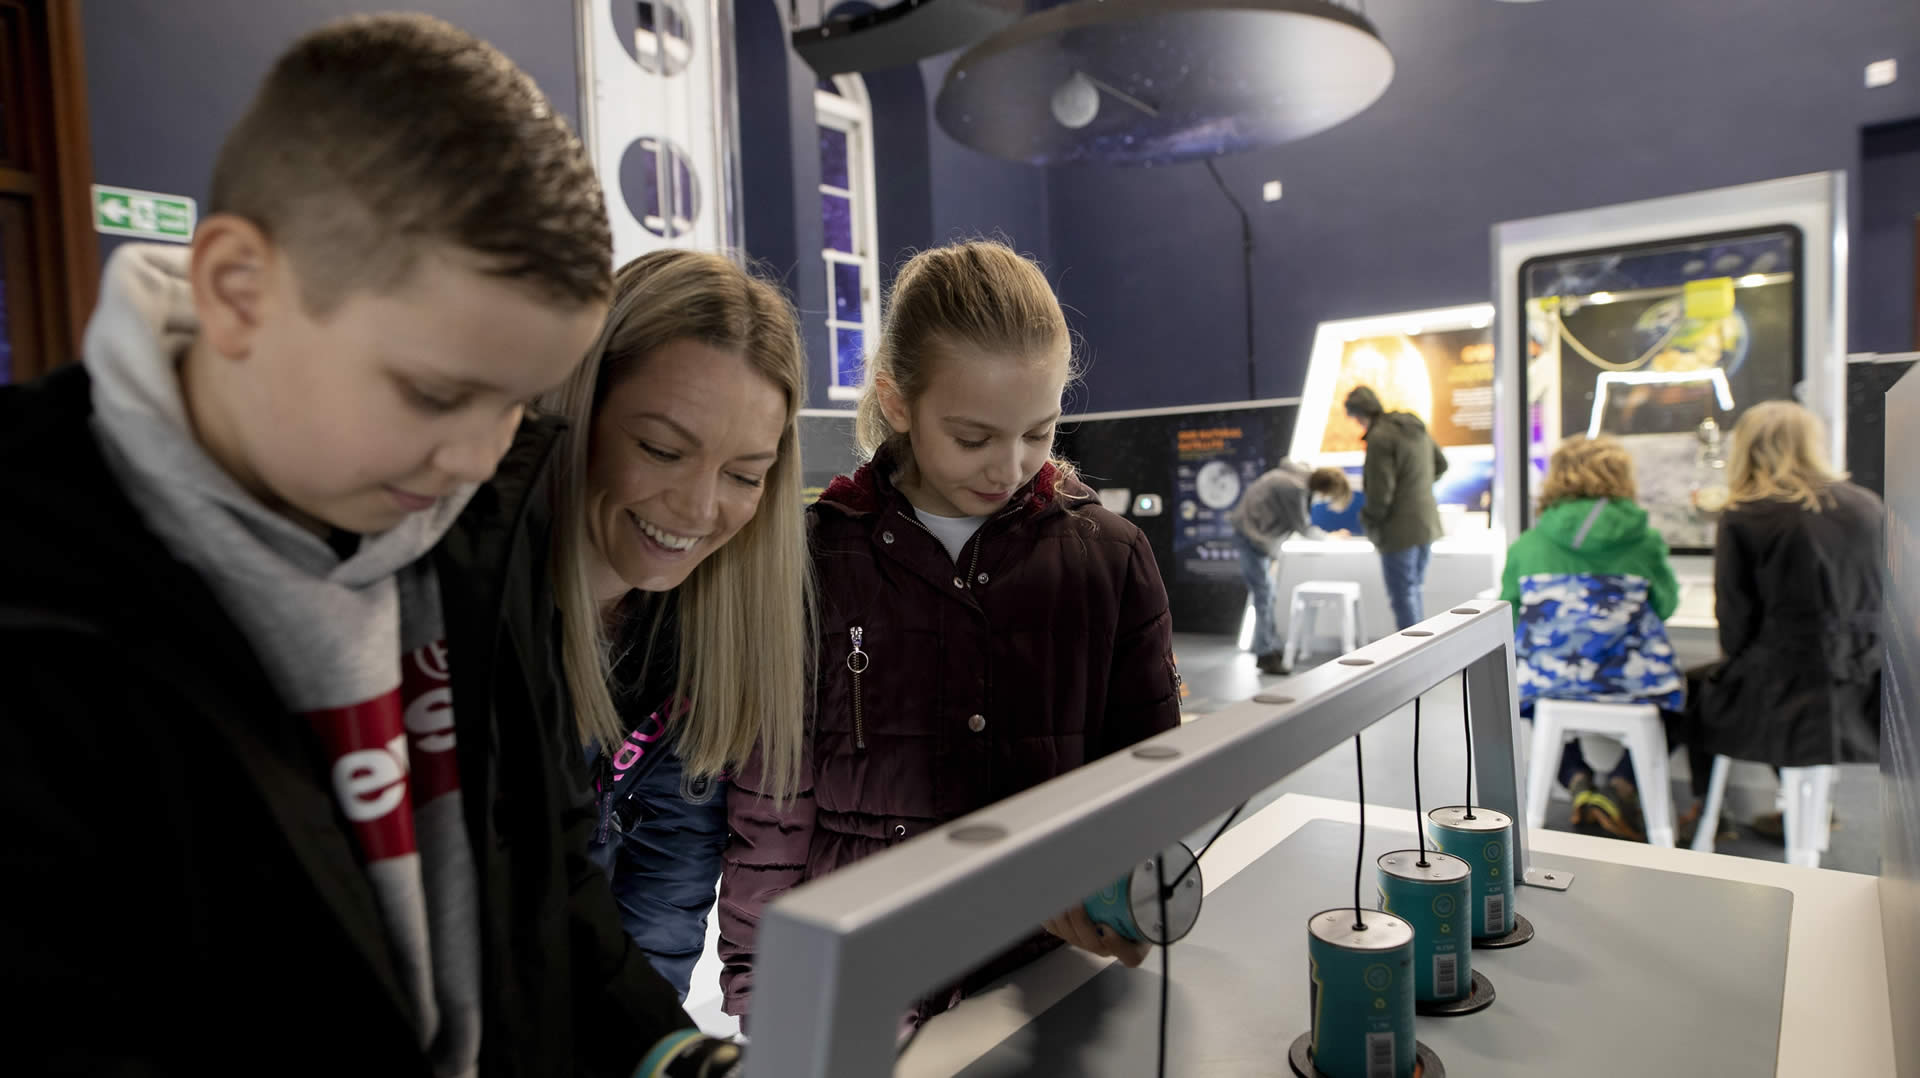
[1492,173,1847,630]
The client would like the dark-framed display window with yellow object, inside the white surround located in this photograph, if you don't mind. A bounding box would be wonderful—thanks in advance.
[1515,225,1805,553]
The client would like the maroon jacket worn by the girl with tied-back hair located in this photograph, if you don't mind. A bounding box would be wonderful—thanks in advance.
[720,457,1181,1015]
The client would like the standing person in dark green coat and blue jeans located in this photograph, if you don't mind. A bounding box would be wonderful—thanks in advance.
[1346,386,1446,628]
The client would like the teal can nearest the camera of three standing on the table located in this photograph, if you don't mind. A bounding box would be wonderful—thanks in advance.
[1308,907,1415,1078]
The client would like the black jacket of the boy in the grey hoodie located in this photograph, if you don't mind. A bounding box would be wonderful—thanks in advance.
[0,367,691,1076]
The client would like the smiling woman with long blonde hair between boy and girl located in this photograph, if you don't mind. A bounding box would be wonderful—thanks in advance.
[547,250,812,999]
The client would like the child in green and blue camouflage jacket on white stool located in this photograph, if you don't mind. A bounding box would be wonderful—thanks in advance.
[1500,436,1686,840]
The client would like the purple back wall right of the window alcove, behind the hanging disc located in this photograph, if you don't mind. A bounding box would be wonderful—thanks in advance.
[1048,0,1920,409]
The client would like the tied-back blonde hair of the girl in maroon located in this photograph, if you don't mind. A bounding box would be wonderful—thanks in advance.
[854,240,1079,477]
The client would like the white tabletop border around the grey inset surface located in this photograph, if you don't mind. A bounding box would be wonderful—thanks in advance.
[895,794,1893,1078]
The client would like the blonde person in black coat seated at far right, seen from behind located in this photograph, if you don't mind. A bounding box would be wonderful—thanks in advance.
[1682,400,1885,832]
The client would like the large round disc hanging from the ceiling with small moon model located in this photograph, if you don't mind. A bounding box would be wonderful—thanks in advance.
[935,0,1394,165]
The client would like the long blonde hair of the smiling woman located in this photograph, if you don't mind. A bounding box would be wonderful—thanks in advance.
[545,250,814,799]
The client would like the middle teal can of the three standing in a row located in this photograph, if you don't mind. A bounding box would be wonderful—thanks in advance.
[1377,849,1478,1003]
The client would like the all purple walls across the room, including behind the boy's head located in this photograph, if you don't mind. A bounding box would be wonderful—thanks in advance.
[83,0,1920,409]
